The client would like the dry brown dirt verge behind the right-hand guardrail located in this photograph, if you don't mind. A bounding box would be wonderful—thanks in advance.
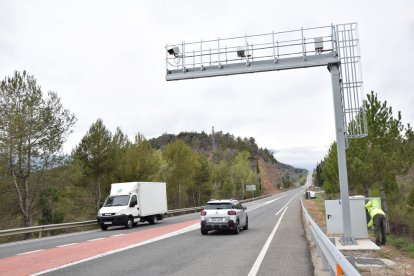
[304,197,414,276]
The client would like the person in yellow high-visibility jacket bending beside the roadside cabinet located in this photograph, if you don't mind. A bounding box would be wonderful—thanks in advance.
[365,200,387,245]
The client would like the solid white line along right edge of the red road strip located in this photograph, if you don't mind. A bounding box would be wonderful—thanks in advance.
[32,222,200,276]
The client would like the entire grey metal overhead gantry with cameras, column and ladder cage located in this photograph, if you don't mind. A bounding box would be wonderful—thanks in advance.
[165,23,367,245]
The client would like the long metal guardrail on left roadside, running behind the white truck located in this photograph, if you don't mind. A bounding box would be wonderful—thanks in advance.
[0,195,270,238]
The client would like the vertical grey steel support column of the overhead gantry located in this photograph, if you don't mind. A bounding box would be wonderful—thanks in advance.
[328,63,355,245]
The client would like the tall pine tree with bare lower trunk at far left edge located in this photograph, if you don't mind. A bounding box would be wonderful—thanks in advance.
[0,71,76,226]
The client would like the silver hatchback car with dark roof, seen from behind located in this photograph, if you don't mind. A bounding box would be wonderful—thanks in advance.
[200,199,249,235]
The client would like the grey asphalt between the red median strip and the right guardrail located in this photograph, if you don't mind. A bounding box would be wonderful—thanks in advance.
[35,184,313,275]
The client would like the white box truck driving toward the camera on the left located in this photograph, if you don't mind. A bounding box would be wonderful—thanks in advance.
[97,182,167,230]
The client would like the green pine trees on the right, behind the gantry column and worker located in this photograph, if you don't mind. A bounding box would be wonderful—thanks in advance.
[314,92,414,238]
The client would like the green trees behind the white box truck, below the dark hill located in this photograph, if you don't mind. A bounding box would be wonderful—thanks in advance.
[72,122,259,209]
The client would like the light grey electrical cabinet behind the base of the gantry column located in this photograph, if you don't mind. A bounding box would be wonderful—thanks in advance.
[325,196,368,239]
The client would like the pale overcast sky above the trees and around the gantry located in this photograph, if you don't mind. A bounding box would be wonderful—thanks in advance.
[0,0,414,169]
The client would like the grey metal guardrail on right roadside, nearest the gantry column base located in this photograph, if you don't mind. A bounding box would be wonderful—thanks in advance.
[300,198,361,276]
